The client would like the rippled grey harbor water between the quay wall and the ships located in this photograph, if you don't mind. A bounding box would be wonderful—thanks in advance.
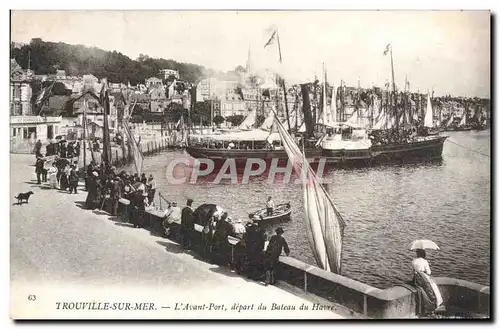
[125,130,491,289]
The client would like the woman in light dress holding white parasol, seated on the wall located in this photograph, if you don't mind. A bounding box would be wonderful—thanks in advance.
[410,240,443,313]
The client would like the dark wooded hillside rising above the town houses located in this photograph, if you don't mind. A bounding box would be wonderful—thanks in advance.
[10,38,211,85]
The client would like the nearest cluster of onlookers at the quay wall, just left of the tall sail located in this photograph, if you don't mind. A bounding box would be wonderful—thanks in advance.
[158,198,290,284]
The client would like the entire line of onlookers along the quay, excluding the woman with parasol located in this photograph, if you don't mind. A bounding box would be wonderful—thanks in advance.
[35,143,290,284]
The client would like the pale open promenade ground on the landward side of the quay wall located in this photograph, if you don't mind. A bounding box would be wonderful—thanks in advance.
[10,154,353,319]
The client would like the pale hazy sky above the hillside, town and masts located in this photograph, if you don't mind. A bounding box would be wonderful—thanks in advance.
[11,11,490,97]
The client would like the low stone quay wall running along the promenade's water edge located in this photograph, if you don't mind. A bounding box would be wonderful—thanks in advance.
[108,199,490,319]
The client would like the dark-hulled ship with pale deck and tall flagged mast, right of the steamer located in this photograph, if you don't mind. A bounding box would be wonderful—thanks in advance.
[314,44,447,166]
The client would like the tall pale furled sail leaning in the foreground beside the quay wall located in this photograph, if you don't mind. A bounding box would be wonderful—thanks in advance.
[276,114,345,274]
